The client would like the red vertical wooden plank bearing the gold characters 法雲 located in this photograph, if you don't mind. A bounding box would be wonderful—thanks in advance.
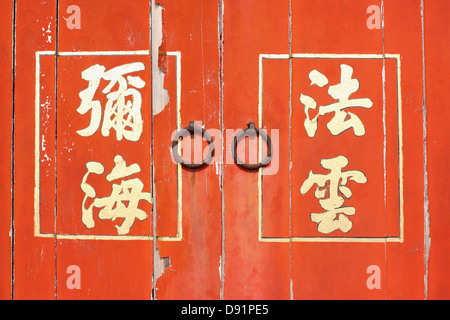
[290,0,390,299]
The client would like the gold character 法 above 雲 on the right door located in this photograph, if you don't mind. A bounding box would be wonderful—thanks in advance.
[300,64,373,138]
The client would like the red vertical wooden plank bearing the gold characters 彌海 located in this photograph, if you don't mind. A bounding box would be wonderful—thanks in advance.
[55,0,153,299]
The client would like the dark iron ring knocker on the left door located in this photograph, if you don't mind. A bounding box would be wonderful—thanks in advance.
[172,121,214,169]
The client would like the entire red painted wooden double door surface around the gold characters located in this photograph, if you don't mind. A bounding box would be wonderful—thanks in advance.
[0,0,449,300]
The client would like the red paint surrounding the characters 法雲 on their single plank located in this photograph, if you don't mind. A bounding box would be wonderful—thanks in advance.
[292,1,388,299]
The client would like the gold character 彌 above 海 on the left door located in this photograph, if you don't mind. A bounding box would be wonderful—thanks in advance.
[77,62,145,141]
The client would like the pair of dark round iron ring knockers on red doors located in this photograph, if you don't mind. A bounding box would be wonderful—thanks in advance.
[172,121,272,170]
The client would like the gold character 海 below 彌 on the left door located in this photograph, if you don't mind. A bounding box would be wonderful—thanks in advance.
[81,156,152,235]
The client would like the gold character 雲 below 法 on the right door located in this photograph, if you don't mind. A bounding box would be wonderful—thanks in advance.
[300,156,367,234]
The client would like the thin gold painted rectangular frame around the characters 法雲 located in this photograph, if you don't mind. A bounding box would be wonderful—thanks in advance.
[258,53,404,243]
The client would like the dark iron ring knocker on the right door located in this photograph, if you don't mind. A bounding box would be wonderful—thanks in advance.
[231,122,272,170]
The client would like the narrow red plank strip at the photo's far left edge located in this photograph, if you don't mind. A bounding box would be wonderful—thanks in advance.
[0,1,15,300]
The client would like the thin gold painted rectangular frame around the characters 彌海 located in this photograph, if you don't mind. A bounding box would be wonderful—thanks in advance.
[34,50,183,241]
